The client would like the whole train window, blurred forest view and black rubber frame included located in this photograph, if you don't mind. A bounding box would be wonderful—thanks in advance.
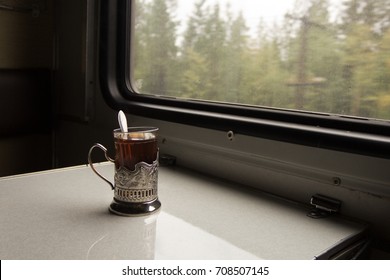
[100,0,390,158]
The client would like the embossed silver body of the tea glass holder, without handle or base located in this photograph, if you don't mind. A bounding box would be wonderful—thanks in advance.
[114,160,158,202]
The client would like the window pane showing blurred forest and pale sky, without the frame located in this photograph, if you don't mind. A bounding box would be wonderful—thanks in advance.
[130,0,390,120]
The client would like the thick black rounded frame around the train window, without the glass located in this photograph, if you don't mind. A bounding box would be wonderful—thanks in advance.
[99,0,390,159]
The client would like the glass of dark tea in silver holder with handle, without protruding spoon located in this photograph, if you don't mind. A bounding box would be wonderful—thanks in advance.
[88,127,161,216]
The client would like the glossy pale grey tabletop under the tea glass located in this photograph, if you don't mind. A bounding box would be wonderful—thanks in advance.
[0,163,365,260]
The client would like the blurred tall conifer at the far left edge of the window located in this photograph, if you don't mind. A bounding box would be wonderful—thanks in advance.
[135,0,178,95]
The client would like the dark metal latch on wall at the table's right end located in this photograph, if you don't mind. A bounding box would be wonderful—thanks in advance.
[307,194,341,219]
